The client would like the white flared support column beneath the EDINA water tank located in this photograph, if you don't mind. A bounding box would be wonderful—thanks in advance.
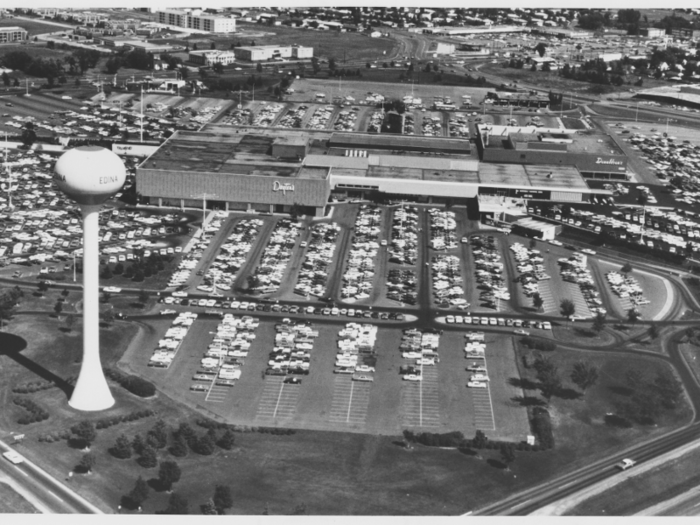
[68,204,114,411]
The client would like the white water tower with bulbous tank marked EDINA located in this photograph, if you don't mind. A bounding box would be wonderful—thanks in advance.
[53,146,126,411]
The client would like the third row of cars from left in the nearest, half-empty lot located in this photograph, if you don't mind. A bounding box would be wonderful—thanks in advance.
[265,319,319,383]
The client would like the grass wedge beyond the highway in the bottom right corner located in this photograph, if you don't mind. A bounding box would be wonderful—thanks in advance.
[566,440,700,516]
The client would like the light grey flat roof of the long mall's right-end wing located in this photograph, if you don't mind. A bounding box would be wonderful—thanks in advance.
[479,162,590,192]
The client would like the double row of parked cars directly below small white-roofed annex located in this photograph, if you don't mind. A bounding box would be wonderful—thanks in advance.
[470,235,510,308]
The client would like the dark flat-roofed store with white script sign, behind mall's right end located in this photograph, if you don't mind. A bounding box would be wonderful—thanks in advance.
[477,125,628,180]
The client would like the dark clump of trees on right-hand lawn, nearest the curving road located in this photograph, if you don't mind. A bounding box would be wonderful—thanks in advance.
[615,368,683,425]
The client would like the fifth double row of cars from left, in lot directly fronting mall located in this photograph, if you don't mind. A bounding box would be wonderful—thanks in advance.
[340,204,382,301]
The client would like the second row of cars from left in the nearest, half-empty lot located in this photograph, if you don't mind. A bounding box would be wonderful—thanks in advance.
[190,314,260,392]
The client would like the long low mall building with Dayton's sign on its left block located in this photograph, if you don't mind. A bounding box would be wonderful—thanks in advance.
[136,124,611,216]
